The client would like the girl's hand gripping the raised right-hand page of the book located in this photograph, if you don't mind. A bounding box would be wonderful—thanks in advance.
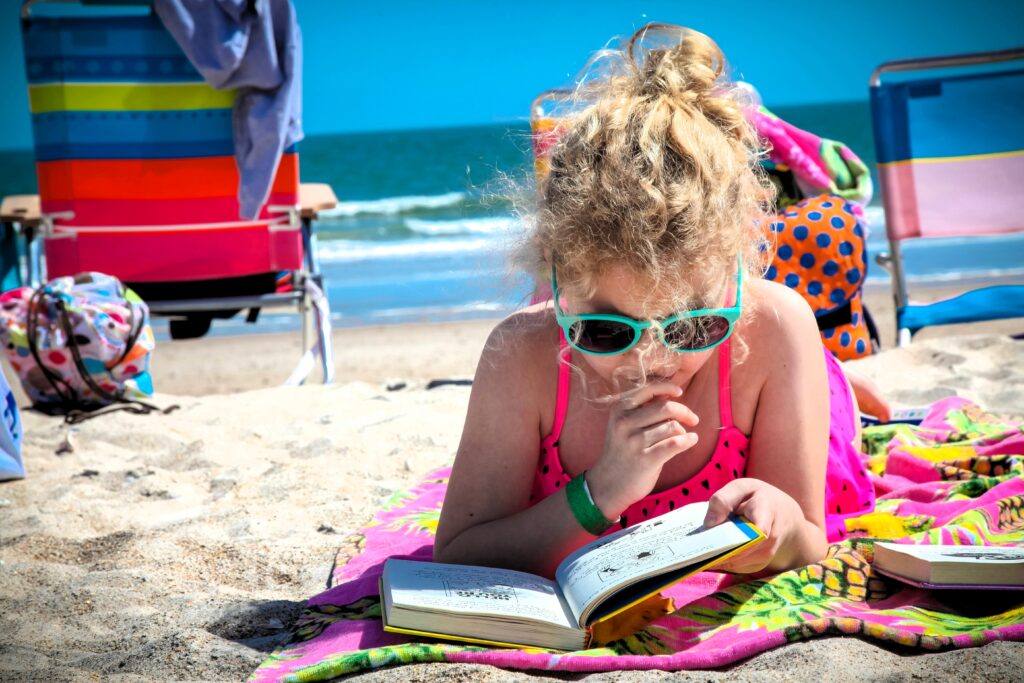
[705,479,805,573]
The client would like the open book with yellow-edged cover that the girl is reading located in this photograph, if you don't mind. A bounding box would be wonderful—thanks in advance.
[380,503,764,650]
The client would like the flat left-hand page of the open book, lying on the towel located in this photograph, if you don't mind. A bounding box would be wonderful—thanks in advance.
[384,560,579,629]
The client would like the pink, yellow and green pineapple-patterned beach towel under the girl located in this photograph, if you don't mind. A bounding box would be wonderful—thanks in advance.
[251,398,1024,681]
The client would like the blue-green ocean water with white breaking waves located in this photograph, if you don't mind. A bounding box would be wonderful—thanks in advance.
[0,102,1024,334]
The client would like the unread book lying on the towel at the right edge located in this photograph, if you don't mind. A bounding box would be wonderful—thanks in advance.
[872,543,1024,590]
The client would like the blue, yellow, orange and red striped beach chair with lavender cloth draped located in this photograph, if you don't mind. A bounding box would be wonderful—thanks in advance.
[14,0,336,381]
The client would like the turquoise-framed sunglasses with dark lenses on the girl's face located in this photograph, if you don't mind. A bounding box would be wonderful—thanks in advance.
[551,263,743,355]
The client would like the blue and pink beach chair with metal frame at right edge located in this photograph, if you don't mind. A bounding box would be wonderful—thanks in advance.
[869,49,1024,346]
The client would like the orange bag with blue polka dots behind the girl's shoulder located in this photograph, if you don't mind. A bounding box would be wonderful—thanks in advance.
[765,195,872,360]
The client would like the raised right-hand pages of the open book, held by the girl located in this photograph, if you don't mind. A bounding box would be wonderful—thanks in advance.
[555,503,756,623]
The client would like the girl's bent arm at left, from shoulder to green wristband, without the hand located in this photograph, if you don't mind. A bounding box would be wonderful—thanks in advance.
[434,313,594,577]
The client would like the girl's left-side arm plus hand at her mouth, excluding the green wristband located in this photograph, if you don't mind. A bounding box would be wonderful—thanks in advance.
[434,313,696,577]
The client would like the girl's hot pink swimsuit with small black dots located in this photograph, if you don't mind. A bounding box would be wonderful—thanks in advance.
[529,337,874,542]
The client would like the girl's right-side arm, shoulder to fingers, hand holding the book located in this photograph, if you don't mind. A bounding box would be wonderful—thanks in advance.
[707,283,830,573]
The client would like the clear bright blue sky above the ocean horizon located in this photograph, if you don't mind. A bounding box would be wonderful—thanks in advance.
[0,0,1024,150]
